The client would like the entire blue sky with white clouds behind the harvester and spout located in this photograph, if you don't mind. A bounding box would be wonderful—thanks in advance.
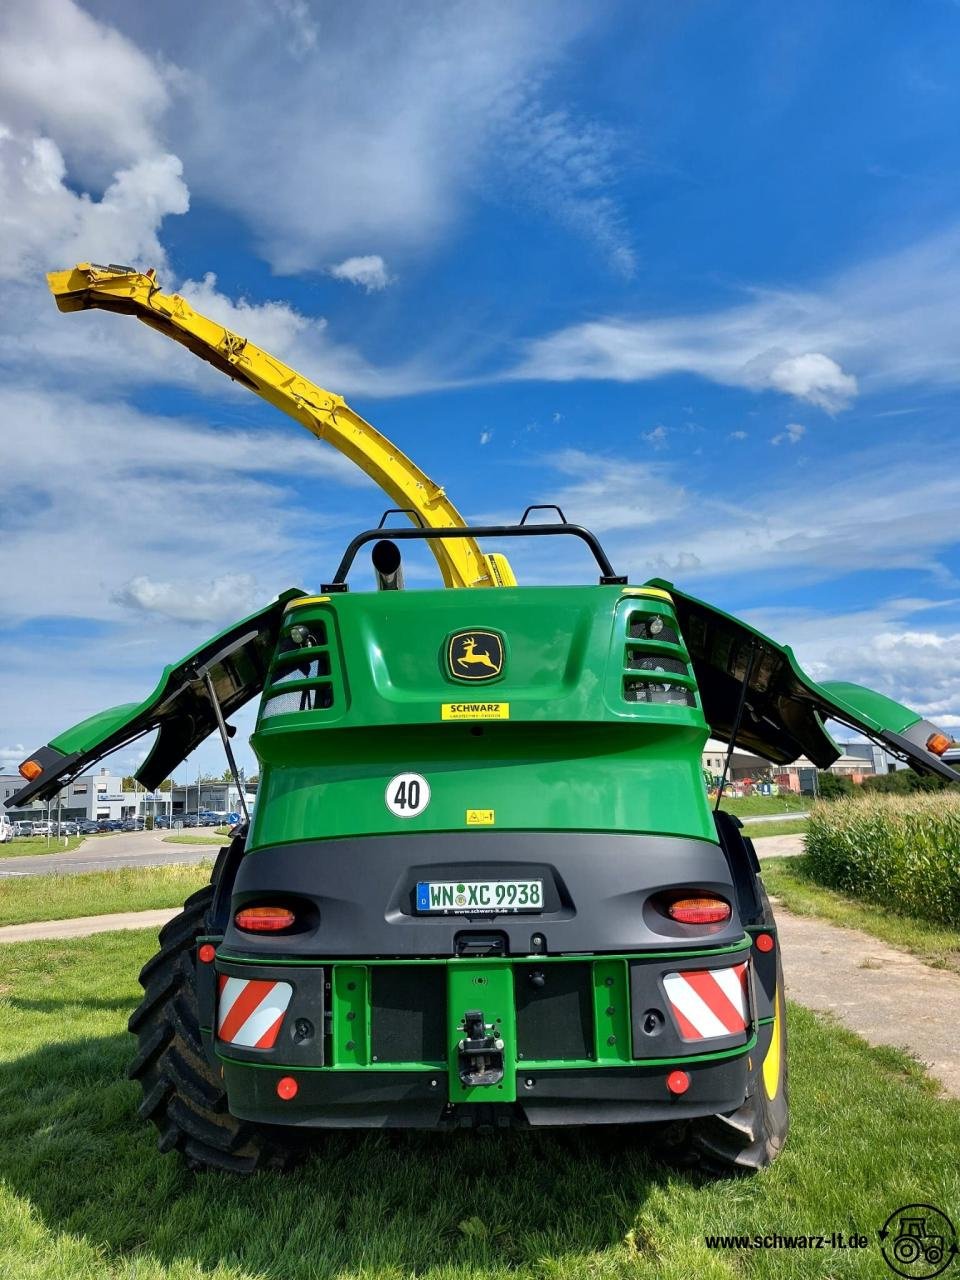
[0,0,960,771]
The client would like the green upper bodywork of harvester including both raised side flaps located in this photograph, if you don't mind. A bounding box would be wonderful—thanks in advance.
[8,579,957,814]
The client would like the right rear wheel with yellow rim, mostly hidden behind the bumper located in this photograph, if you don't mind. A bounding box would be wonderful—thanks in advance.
[660,891,790,1176]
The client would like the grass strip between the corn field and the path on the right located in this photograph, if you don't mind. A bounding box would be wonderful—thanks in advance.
[760,858,960,973]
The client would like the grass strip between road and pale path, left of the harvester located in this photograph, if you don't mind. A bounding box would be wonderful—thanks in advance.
[0,861,212,926]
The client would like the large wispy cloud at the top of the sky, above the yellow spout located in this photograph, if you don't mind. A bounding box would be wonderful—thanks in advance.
[97,0,632,274]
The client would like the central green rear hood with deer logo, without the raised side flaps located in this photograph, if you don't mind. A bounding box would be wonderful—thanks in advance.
[247,586,716,849]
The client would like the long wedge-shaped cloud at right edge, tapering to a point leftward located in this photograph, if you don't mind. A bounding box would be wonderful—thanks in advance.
[509,224,960,412]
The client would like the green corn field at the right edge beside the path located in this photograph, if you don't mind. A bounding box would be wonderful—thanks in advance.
[805,791,960,925]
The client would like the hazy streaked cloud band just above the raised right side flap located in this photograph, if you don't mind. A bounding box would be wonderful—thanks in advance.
[522,444,960,591]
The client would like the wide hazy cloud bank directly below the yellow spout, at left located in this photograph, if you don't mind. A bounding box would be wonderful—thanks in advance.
[0,387,379,622]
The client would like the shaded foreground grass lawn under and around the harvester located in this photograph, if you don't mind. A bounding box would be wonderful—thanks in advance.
[0,932,960,1280]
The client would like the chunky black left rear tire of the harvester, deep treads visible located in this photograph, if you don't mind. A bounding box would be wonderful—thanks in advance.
[127,873,294,1174]
